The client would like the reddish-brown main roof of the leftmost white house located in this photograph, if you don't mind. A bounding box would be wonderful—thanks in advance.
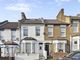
[0,22,18,29]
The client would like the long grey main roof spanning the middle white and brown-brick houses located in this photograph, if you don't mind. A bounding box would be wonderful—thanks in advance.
[19,19,69,24]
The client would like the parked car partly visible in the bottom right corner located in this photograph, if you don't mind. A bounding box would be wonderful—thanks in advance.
[58,51,80,60]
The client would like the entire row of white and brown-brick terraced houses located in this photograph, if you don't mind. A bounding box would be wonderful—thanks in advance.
[0,9,80,60]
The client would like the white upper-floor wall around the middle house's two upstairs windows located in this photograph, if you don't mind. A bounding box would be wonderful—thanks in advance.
[21,24,44,41]
